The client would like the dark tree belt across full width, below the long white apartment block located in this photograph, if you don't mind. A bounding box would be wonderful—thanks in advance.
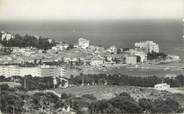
[0,74,184,90]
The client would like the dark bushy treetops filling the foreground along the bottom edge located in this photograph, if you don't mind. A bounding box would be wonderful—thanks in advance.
[0,85,183,114]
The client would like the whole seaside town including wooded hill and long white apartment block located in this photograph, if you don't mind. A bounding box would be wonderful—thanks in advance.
[0,32,180,77]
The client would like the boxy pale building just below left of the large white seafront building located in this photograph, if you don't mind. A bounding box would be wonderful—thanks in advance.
[125,55,137,65]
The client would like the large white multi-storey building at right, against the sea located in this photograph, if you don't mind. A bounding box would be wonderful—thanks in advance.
[135,41,159,53]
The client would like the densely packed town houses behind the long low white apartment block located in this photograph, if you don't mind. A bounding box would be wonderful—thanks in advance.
[0,36,159,66]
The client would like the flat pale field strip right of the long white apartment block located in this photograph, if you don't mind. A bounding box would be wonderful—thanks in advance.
[63,65,184,77]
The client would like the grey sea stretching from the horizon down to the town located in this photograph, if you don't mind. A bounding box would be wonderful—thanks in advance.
[0,19,184,58]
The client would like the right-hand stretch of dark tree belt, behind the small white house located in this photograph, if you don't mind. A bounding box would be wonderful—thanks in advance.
[71,74,184,87]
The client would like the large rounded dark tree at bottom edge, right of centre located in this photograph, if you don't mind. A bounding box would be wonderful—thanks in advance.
[89,93,142,114]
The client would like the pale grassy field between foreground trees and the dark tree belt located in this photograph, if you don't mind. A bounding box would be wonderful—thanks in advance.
[55,85,172,100]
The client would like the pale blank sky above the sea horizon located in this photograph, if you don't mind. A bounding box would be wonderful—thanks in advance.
[0,0,184,20]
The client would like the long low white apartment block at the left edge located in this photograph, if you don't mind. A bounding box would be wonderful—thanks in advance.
[0,65,65,77]
